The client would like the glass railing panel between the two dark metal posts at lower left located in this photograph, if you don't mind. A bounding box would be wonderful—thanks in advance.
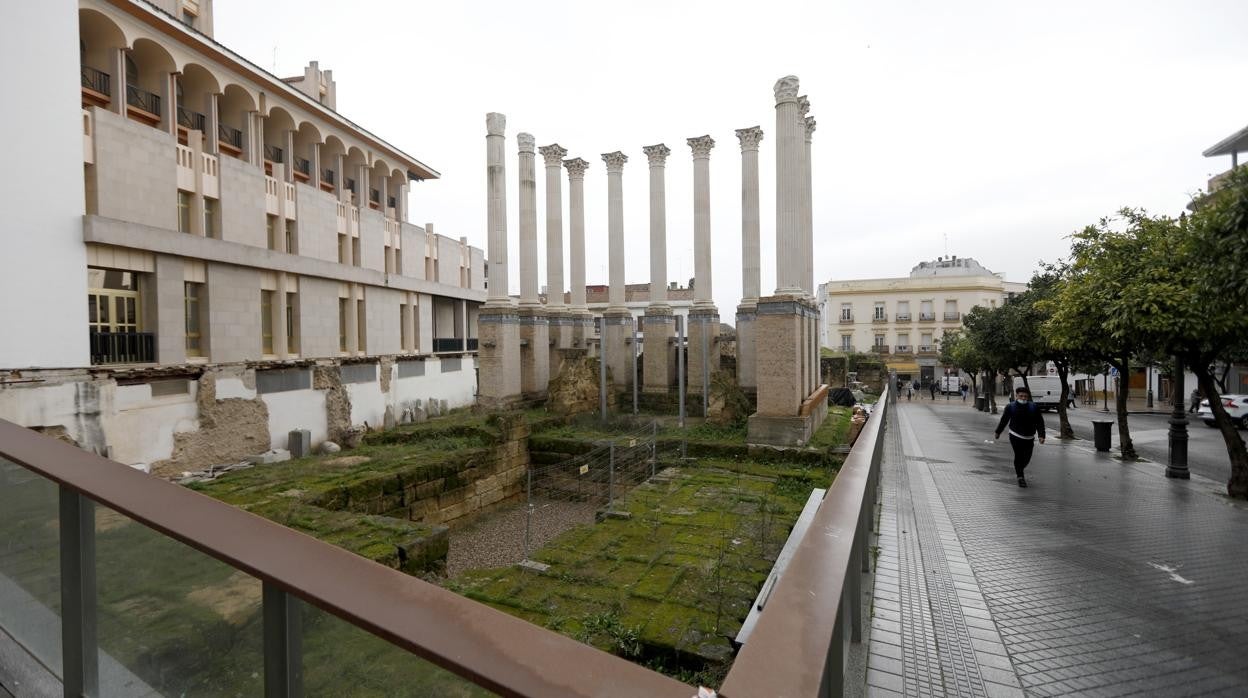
[95,504,265,697]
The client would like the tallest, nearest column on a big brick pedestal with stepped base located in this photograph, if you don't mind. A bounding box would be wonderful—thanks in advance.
[746,75,827,447]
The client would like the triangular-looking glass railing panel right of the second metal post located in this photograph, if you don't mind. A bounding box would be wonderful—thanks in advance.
[300,603,495,698]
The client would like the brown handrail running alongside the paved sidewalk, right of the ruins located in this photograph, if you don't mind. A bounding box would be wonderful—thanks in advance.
[719,388,891,698]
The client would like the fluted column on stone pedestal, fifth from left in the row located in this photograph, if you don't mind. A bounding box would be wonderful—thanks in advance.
[600,150,633,388]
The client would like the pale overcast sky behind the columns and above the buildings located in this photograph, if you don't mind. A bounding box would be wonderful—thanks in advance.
[216,0,1248,312]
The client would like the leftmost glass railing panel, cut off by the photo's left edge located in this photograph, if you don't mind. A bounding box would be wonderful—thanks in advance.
[0,458,61,679]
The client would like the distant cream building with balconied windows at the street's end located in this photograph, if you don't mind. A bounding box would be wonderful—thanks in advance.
[819,256,1027,382]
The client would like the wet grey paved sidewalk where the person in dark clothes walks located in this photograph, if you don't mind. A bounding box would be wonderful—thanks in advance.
[867,401,1248,697]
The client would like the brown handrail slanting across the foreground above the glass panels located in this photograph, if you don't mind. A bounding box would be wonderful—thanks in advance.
[0,420,696,698]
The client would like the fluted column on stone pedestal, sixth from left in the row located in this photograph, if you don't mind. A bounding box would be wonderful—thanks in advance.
[641,144,676,395]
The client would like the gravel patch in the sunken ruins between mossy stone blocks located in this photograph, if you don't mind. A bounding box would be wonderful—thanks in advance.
[447,498,600,578]
